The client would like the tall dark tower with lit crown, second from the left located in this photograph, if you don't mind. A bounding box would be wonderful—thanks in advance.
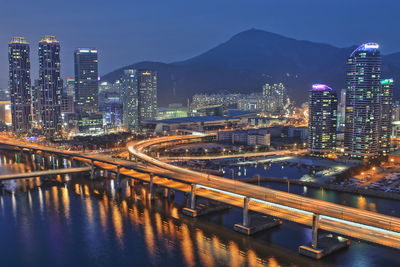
[39,35,62,136]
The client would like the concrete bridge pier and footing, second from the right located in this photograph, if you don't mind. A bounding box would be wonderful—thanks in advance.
[233,197,282,235]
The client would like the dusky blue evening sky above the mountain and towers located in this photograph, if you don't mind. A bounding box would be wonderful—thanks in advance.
[0,0,400,87]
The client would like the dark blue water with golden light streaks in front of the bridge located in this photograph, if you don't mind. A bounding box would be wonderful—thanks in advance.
[0,152,393,266]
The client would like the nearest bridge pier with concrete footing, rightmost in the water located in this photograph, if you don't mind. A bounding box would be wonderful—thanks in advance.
[299,214,350,260]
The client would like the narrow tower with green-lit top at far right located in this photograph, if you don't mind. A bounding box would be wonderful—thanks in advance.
[379,79,393,155]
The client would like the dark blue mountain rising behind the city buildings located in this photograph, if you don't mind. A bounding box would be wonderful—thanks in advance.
[102,29,400,105]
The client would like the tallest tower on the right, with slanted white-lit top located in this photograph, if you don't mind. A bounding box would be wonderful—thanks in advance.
[344,43,382,159]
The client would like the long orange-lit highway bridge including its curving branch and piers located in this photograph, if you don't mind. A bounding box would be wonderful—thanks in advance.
[0,136,400,258]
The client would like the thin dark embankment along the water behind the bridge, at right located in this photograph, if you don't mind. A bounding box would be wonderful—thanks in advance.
[237,177,400,200]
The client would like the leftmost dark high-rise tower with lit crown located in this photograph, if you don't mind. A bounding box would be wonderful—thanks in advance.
[8,37,32,133]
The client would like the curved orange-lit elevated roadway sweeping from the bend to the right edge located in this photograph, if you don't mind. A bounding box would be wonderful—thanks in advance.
[128,136,400,249]
